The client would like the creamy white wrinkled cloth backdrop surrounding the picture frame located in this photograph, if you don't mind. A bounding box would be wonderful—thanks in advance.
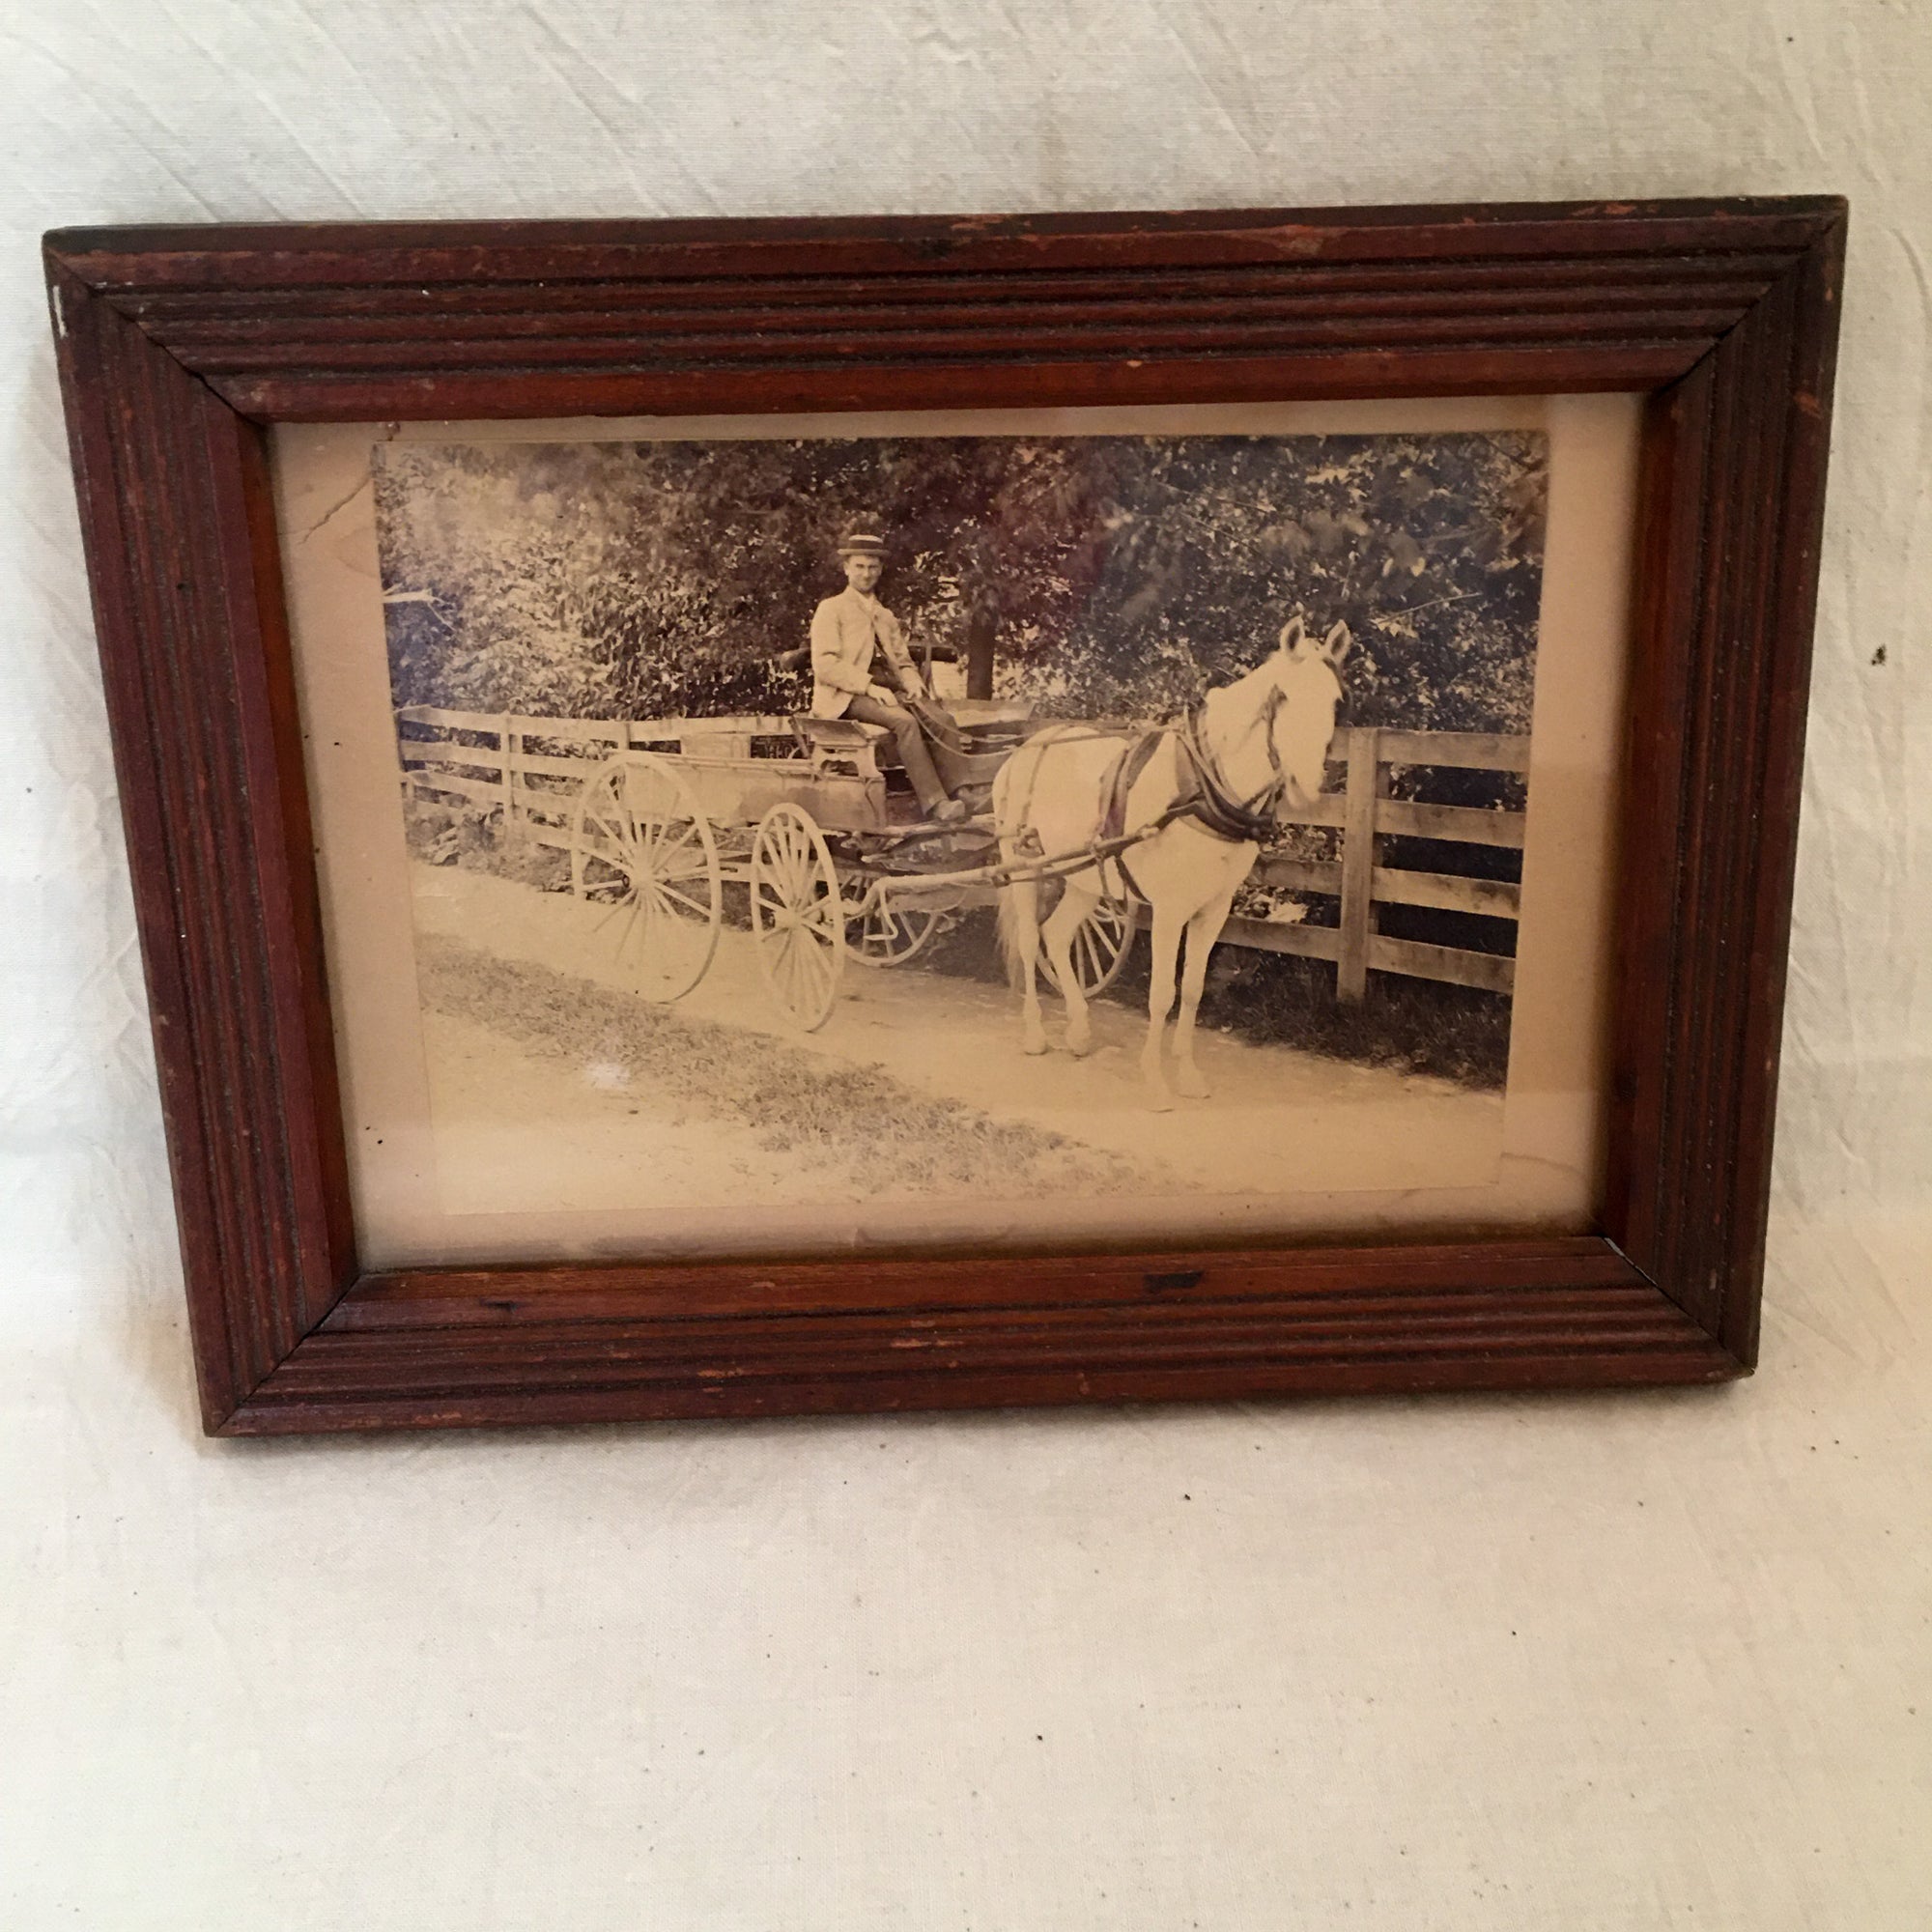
[0,0,1932,1932]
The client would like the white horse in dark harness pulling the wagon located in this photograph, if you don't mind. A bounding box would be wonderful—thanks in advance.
[993,616,1349,1107]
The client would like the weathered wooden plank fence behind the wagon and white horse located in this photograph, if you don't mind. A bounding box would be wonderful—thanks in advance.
[396,705,1530,1001]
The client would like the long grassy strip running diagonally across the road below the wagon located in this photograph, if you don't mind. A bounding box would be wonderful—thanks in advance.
[417,933,1144,1198]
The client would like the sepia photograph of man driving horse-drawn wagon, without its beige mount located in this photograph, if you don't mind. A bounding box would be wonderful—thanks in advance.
[371,429,1549,1213]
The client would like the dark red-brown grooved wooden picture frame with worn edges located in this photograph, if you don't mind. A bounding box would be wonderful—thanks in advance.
[46,199,1845,1434]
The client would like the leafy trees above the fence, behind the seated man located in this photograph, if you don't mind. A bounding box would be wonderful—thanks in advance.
[377,433,1546,730]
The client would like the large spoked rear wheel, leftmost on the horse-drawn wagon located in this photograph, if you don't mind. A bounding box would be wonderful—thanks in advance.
[570,752,724,1001]
